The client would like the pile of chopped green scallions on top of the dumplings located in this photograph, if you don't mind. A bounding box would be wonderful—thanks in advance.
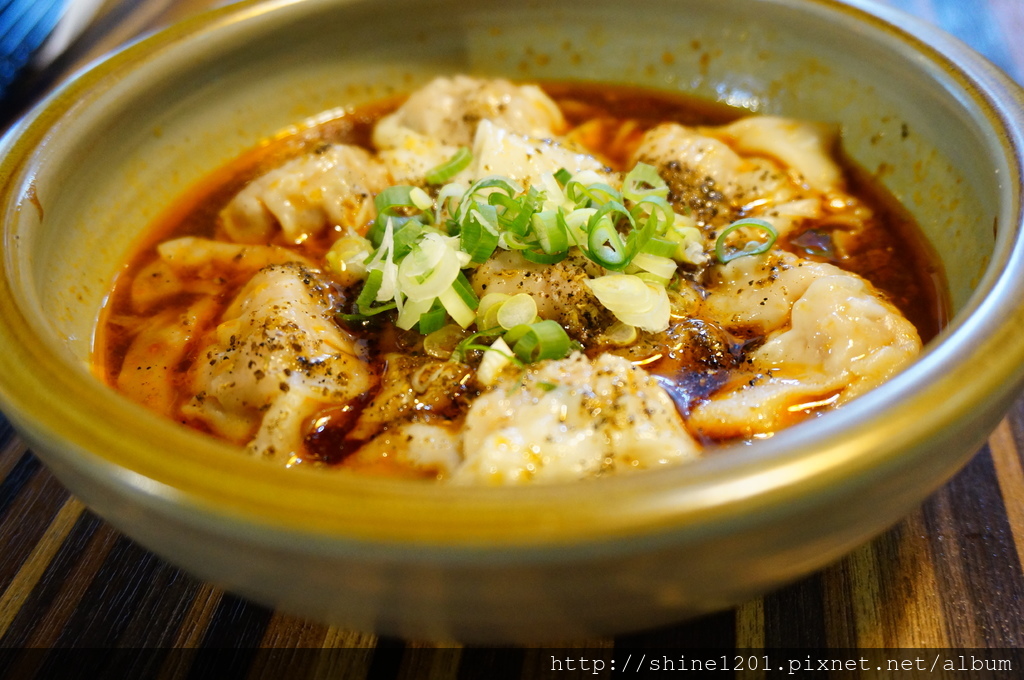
[351,161,696,346]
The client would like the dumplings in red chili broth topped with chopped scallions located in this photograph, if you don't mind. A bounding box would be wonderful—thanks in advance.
[95,76,945,484]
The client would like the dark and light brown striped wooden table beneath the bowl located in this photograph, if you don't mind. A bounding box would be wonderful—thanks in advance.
[0,0,1024,678]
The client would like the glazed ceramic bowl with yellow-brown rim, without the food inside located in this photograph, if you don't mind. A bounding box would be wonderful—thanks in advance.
[0,0,1024,642]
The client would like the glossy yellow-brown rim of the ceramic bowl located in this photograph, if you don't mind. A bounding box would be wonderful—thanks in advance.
[0,0,1024,550]
